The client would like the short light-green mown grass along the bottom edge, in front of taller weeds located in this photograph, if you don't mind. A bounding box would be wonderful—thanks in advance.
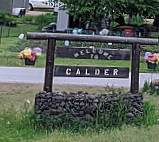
[30,125,159,142]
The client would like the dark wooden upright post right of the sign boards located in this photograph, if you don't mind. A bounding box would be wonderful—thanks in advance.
[130,44,140,94]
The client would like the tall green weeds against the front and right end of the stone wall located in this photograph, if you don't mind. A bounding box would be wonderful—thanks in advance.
[33,101,159,134]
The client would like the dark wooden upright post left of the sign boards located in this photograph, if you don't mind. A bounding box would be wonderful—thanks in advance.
[44,39,56,92]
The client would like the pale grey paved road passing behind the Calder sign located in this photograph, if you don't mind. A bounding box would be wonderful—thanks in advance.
[0,67,159,88]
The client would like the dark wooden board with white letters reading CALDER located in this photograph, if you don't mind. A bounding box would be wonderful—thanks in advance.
[54,66,129,78]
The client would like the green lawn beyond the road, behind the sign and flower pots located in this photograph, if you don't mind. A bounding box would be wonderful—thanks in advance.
[0,15,159,73]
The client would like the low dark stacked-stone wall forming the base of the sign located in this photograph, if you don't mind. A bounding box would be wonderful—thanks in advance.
[35,91,143,121]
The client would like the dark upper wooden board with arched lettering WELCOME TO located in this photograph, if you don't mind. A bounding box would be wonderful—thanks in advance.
[56,47,130,60]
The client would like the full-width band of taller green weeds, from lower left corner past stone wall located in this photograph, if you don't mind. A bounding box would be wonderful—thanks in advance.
[0,102,159,142]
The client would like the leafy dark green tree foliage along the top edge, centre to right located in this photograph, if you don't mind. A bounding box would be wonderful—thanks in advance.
[61,0,159,28]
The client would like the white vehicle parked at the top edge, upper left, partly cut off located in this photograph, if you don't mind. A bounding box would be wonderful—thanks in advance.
[29,0,53,10]
